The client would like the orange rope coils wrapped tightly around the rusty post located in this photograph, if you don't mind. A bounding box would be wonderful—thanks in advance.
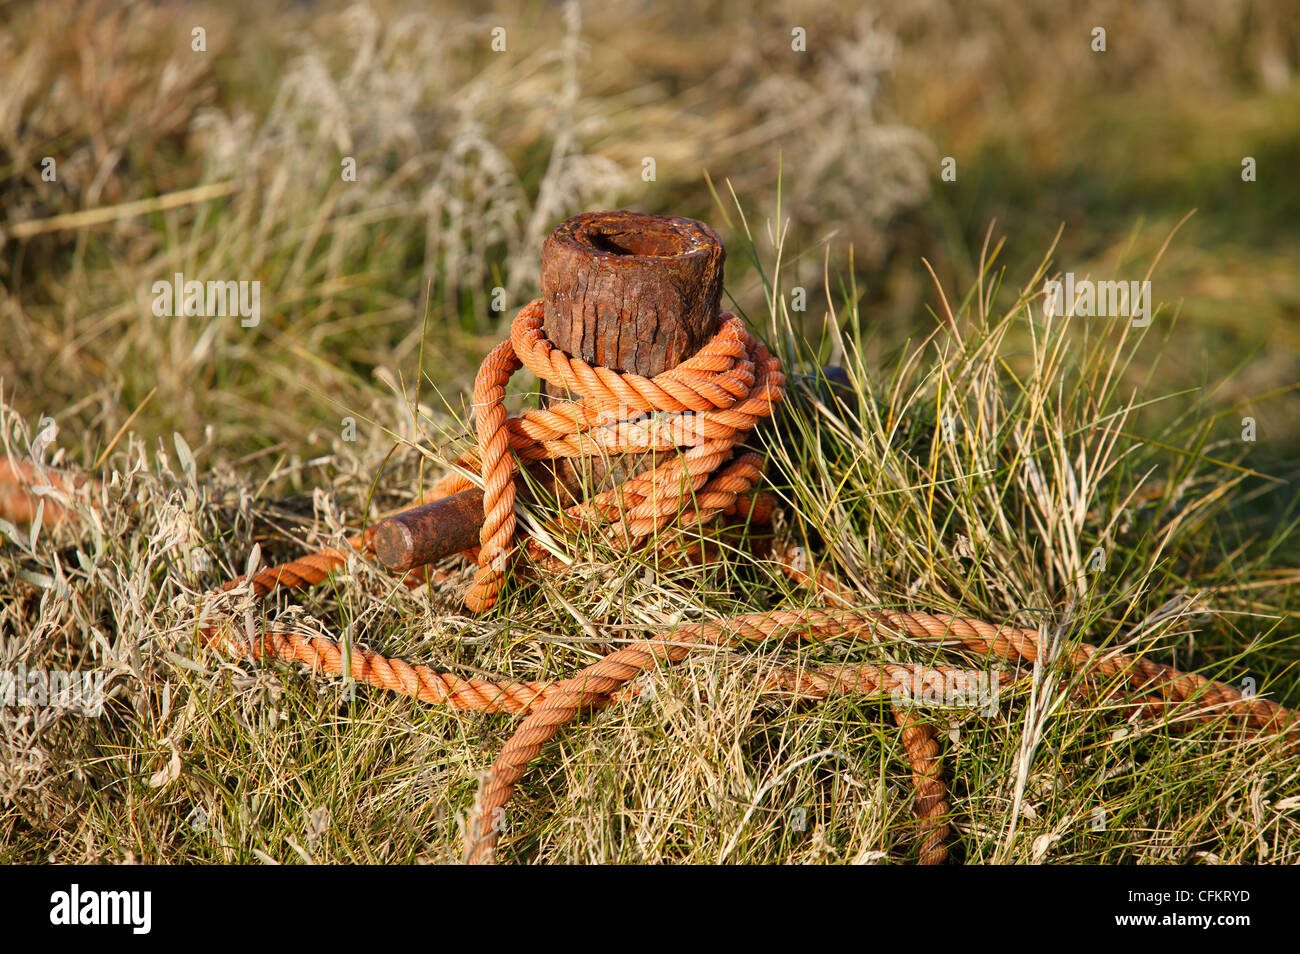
[457,299,785,612]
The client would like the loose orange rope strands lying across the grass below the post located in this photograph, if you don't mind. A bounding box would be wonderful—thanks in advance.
[192,522,1297,862]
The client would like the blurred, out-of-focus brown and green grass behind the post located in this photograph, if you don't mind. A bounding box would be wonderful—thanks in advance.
[0,0,1300,469]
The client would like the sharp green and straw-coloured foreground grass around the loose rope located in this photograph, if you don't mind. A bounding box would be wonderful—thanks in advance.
[4,188,1300,863]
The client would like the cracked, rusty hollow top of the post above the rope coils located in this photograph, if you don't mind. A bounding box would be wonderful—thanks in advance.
[542,211,727,377]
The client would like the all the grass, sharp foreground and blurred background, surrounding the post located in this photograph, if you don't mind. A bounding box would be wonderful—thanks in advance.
[0,3,1300,863]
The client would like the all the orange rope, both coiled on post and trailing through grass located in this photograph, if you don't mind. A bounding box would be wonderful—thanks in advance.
[0,302,1300,863]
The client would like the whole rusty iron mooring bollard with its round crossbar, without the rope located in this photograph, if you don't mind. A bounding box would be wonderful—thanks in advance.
[374,212,725,571]
